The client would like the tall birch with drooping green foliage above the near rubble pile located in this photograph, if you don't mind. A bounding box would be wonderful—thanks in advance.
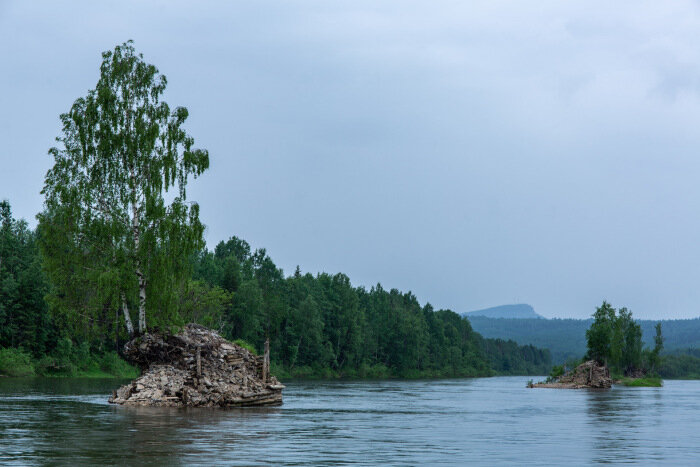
[38,41,209,336]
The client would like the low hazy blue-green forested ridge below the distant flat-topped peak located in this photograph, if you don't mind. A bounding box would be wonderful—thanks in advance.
[468,316,700,363]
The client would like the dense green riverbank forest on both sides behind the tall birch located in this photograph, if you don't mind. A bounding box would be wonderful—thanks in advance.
[0,201,551,378]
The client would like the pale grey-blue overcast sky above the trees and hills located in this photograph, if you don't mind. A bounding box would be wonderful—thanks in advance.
[0,0,700,319]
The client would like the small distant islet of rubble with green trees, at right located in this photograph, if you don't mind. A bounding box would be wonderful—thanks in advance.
[527,301,663,389]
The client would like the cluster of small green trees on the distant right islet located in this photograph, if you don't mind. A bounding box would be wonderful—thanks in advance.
[586,301,663,375]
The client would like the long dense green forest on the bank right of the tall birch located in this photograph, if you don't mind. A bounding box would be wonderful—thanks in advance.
[194,237,551,376]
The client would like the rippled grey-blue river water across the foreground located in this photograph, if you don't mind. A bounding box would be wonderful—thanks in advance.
[0,377,700,465]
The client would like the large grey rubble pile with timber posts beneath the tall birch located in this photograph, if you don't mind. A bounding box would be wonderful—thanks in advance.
[109,324,284,407]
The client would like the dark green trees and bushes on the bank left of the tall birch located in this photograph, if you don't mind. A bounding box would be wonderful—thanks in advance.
[0,201,135,376]
